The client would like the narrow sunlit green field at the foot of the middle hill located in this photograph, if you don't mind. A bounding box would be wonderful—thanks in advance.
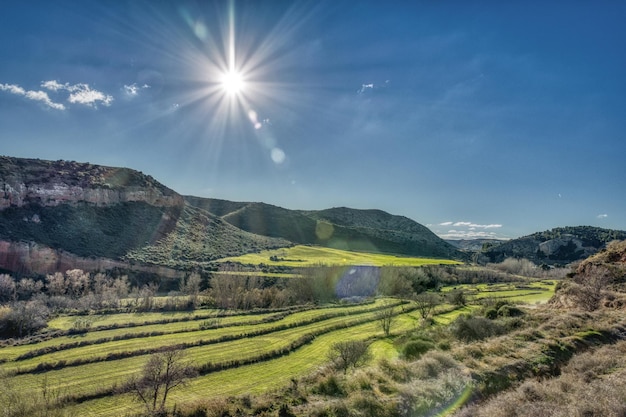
[219,245,460,267]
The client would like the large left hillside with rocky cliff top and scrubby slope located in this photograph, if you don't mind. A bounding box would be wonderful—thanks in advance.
[0,157,290,273]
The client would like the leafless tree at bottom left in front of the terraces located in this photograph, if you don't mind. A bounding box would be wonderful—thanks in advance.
[125,349,197,416]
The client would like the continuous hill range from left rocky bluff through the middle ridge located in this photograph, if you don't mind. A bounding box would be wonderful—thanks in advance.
[0,157,462,276]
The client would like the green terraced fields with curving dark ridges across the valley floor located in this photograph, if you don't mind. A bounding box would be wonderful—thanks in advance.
[0,283,554,416]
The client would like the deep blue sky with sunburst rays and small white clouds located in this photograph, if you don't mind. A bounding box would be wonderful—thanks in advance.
[0,0,626,238]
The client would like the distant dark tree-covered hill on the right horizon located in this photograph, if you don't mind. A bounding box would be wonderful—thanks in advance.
[483,226,626,264]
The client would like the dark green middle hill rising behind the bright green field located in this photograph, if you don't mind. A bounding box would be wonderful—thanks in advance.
[185,196,462,259]
